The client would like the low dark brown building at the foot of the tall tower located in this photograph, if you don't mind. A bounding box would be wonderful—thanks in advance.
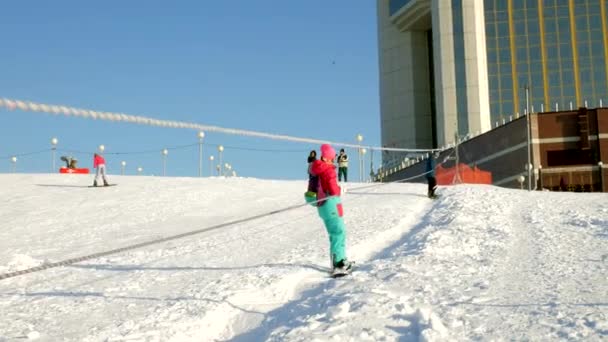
[375,107,608,192]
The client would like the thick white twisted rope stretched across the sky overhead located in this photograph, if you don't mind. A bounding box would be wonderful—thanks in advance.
[0,98,441,152]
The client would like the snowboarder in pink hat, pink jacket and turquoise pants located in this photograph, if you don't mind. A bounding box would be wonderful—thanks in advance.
[311,144,352,277]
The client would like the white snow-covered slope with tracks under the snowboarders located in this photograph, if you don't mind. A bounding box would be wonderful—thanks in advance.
[0,175,608,341]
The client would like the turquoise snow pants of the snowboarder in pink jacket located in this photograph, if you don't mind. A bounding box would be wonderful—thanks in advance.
[317,197,346,263]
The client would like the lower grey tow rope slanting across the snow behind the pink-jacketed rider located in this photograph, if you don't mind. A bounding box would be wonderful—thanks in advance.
[0,159,443,281]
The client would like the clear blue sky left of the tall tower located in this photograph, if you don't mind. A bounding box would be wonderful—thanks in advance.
[0,0,380,180]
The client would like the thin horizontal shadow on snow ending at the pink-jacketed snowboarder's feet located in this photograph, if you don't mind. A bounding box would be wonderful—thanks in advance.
[70,263,329,272]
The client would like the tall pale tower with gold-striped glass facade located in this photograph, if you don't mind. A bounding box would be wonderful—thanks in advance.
[377,0,608,154]
